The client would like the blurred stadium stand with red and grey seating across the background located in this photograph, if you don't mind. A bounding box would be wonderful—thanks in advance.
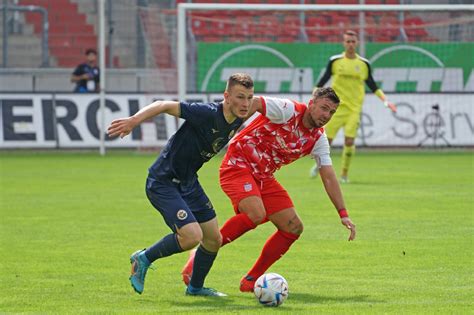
[0,0,472,91]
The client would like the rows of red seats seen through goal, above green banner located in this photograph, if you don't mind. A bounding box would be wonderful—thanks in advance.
[183,0,433,42]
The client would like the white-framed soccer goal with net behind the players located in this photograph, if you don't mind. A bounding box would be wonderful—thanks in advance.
[177,1,474,146]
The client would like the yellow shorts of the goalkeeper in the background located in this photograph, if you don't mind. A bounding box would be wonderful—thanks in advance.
[324,106,360,139]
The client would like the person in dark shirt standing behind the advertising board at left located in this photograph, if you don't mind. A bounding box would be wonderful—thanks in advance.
[71,48,100,93]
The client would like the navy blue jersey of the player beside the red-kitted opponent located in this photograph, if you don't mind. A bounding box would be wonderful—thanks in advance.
[149,102,243,183]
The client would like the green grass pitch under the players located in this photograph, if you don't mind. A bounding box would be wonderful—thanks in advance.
[0,150,474,314]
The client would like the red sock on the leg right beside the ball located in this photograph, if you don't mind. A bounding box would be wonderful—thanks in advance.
[247,230,300,280]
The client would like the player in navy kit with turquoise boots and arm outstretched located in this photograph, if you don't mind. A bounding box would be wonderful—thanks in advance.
[108,73,253,296]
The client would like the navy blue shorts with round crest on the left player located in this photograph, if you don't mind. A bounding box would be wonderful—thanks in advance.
[145,176,216,232]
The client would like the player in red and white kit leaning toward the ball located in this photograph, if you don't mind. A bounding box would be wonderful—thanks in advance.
[182,88,356,292]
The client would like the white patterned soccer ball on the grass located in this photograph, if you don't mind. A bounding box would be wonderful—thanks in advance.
[253,273,288,306]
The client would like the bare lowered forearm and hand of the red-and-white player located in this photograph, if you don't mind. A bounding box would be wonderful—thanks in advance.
[319,165,356,241]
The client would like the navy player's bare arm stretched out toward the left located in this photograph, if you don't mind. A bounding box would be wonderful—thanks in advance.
[107,101,180,138]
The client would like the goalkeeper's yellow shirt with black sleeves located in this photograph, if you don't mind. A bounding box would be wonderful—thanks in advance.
[316,52,378,112]
